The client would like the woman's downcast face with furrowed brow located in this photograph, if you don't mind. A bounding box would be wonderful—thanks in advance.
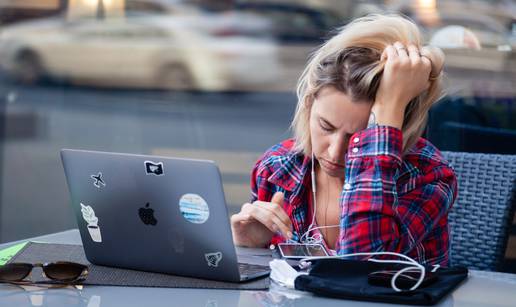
[310,87,372,178]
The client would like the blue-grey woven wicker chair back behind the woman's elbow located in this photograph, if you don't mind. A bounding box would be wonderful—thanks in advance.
[443,152,516,271]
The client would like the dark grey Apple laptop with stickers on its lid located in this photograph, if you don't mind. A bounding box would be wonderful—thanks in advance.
[61,149,270,282]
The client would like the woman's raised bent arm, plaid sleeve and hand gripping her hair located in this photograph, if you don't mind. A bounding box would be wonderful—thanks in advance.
[337,42,457,262]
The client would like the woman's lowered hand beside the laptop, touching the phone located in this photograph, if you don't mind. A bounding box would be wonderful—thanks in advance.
[231,192,292,247]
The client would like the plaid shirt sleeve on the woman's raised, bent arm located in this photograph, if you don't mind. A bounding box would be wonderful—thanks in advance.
[336,126,456,255]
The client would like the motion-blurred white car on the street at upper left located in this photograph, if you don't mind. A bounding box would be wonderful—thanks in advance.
[0,15,279,91]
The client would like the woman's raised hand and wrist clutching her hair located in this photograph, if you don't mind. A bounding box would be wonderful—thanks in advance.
[372,42,432,129]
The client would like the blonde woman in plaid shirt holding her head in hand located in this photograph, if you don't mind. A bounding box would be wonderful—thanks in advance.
[231,14,457,265]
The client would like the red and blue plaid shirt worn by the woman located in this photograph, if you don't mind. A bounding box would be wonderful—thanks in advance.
[251,126,457,266]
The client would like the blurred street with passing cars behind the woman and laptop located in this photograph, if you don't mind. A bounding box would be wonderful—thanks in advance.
[0,0,516,272]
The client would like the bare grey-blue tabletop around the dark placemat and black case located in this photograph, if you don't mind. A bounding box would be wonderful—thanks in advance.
[0,229,516,307]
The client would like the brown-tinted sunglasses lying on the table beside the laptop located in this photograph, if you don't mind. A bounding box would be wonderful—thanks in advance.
[0,261,88,283]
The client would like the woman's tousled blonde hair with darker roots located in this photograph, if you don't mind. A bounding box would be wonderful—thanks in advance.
[291,14,444,155]
